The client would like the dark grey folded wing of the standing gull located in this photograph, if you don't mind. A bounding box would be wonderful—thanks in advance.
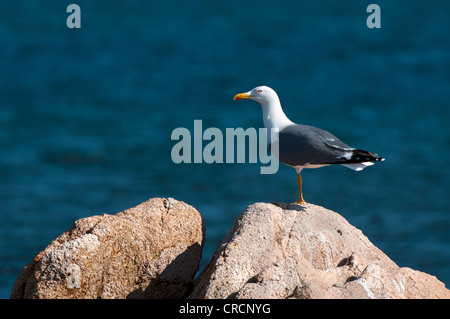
[271,124,354,166]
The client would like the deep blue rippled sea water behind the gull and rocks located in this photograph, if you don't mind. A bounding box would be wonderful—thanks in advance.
[0,0,450,298]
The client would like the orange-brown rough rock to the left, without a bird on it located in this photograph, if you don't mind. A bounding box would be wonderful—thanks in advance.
[11,198,204,298]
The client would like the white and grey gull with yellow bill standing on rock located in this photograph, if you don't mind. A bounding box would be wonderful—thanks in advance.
[233,86,385,204]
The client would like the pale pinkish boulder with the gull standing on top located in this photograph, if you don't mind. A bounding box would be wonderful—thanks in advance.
[189,203,450,298]
